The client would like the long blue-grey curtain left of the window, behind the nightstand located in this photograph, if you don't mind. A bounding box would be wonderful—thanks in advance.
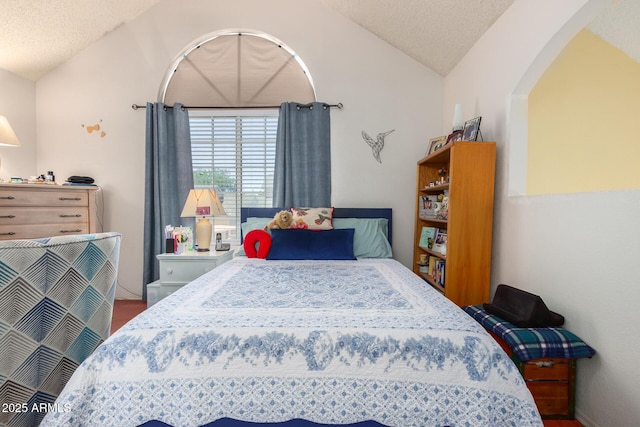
[142,103,193,300]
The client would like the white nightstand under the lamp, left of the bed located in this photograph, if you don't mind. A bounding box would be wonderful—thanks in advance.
[147,250,233,307]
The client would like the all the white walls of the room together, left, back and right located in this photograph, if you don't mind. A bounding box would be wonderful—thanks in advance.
[5,0,640,427]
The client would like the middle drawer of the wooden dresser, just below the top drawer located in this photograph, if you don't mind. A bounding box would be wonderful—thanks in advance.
[0,206,89,225]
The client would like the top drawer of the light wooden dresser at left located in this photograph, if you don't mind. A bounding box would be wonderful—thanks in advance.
[0,189,89,206]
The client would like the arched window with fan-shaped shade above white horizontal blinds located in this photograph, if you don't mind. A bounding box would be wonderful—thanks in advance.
[158,30,316,241]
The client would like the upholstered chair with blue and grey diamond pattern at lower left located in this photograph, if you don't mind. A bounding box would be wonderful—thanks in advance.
[0,233,121,426]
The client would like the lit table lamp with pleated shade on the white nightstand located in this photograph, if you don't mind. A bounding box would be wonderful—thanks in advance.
[180,188,227,252]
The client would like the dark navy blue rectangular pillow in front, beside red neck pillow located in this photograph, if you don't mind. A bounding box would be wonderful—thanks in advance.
[267,228,356,260]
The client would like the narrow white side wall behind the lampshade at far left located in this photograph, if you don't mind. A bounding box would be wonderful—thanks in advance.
[0,69,35,181]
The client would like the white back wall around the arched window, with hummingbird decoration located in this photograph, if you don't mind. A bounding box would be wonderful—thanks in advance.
[37,0,443,298]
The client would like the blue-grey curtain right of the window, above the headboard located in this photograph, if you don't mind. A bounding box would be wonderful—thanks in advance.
[273,102,331,208]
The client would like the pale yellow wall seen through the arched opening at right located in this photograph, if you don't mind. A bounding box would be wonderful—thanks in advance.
[527,30,640,194]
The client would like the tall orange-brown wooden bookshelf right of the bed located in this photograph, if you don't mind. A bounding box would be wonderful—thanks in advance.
[413,141,496,306]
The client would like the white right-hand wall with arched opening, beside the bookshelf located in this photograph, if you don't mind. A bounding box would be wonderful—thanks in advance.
[443,0,640,427]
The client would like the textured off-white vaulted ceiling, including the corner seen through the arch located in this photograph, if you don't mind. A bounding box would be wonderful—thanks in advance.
[0,0,640,81]
